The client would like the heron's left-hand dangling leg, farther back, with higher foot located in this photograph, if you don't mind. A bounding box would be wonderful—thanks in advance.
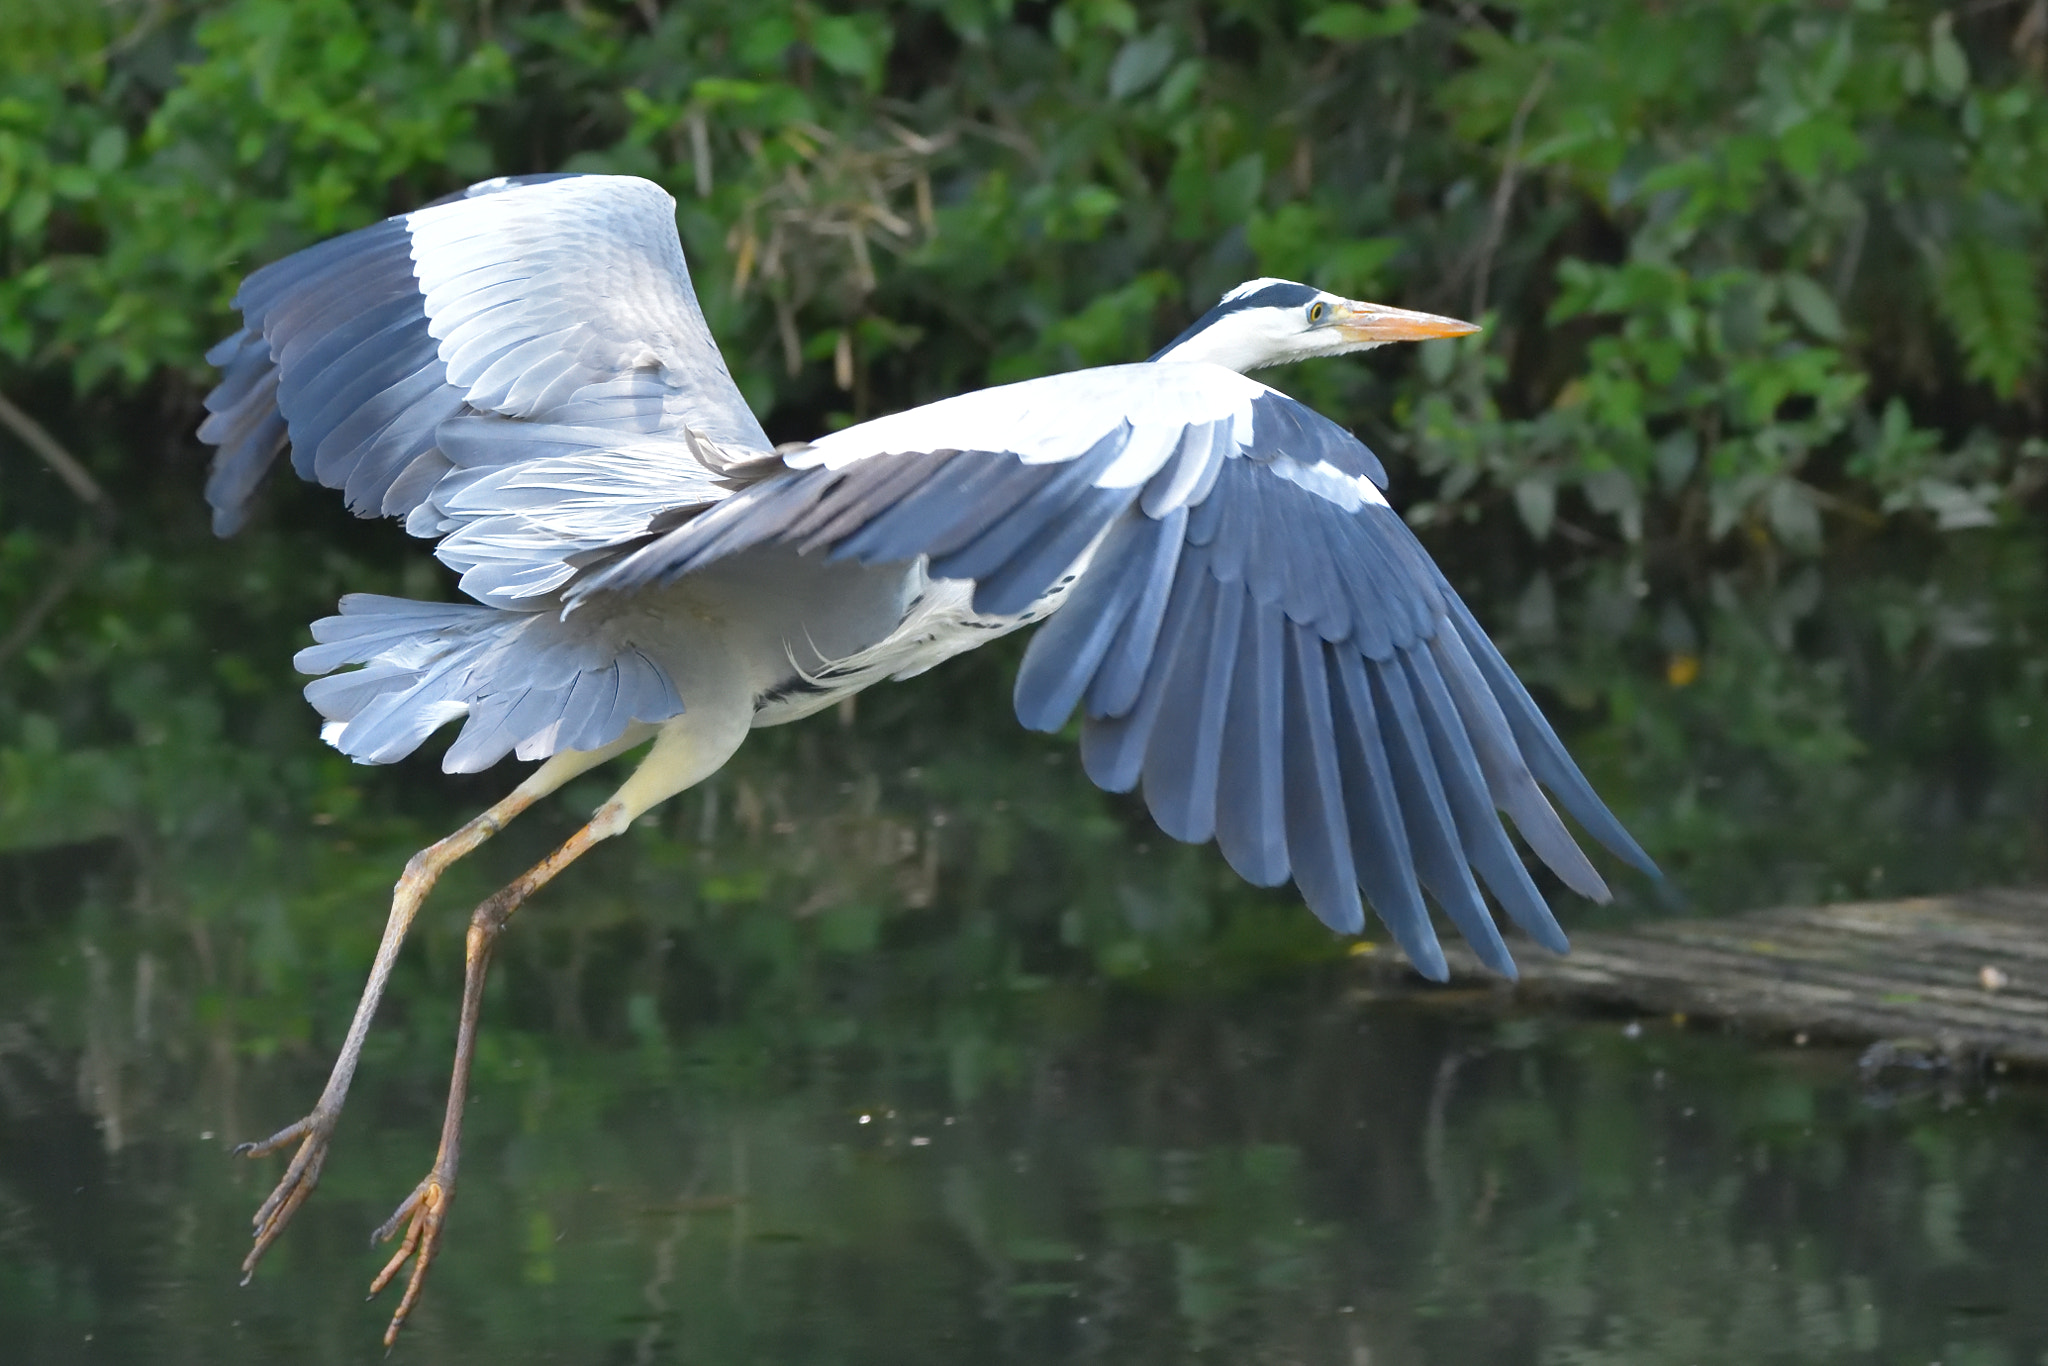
[236,729,647,1284]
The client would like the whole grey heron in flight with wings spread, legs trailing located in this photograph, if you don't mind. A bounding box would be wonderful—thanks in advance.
[199,176,1655,1343]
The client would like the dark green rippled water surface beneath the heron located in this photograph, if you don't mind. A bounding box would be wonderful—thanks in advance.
[0,520,2048,1366]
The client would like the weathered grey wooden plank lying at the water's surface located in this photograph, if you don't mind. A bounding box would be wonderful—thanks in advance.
[1448,891,2048,1065]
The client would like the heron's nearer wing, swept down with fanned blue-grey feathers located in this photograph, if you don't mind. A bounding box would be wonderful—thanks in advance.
[569,365,1655,977]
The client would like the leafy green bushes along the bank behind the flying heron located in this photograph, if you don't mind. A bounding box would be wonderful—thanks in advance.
[0,0,2048,549]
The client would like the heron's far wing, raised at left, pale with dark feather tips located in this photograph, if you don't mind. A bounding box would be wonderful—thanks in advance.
[199,176,768,600]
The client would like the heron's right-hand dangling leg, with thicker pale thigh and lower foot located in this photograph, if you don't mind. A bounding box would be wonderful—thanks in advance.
[371,705,752,1348]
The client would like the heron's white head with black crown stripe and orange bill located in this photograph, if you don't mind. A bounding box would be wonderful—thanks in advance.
[1153,279,1479,373]
